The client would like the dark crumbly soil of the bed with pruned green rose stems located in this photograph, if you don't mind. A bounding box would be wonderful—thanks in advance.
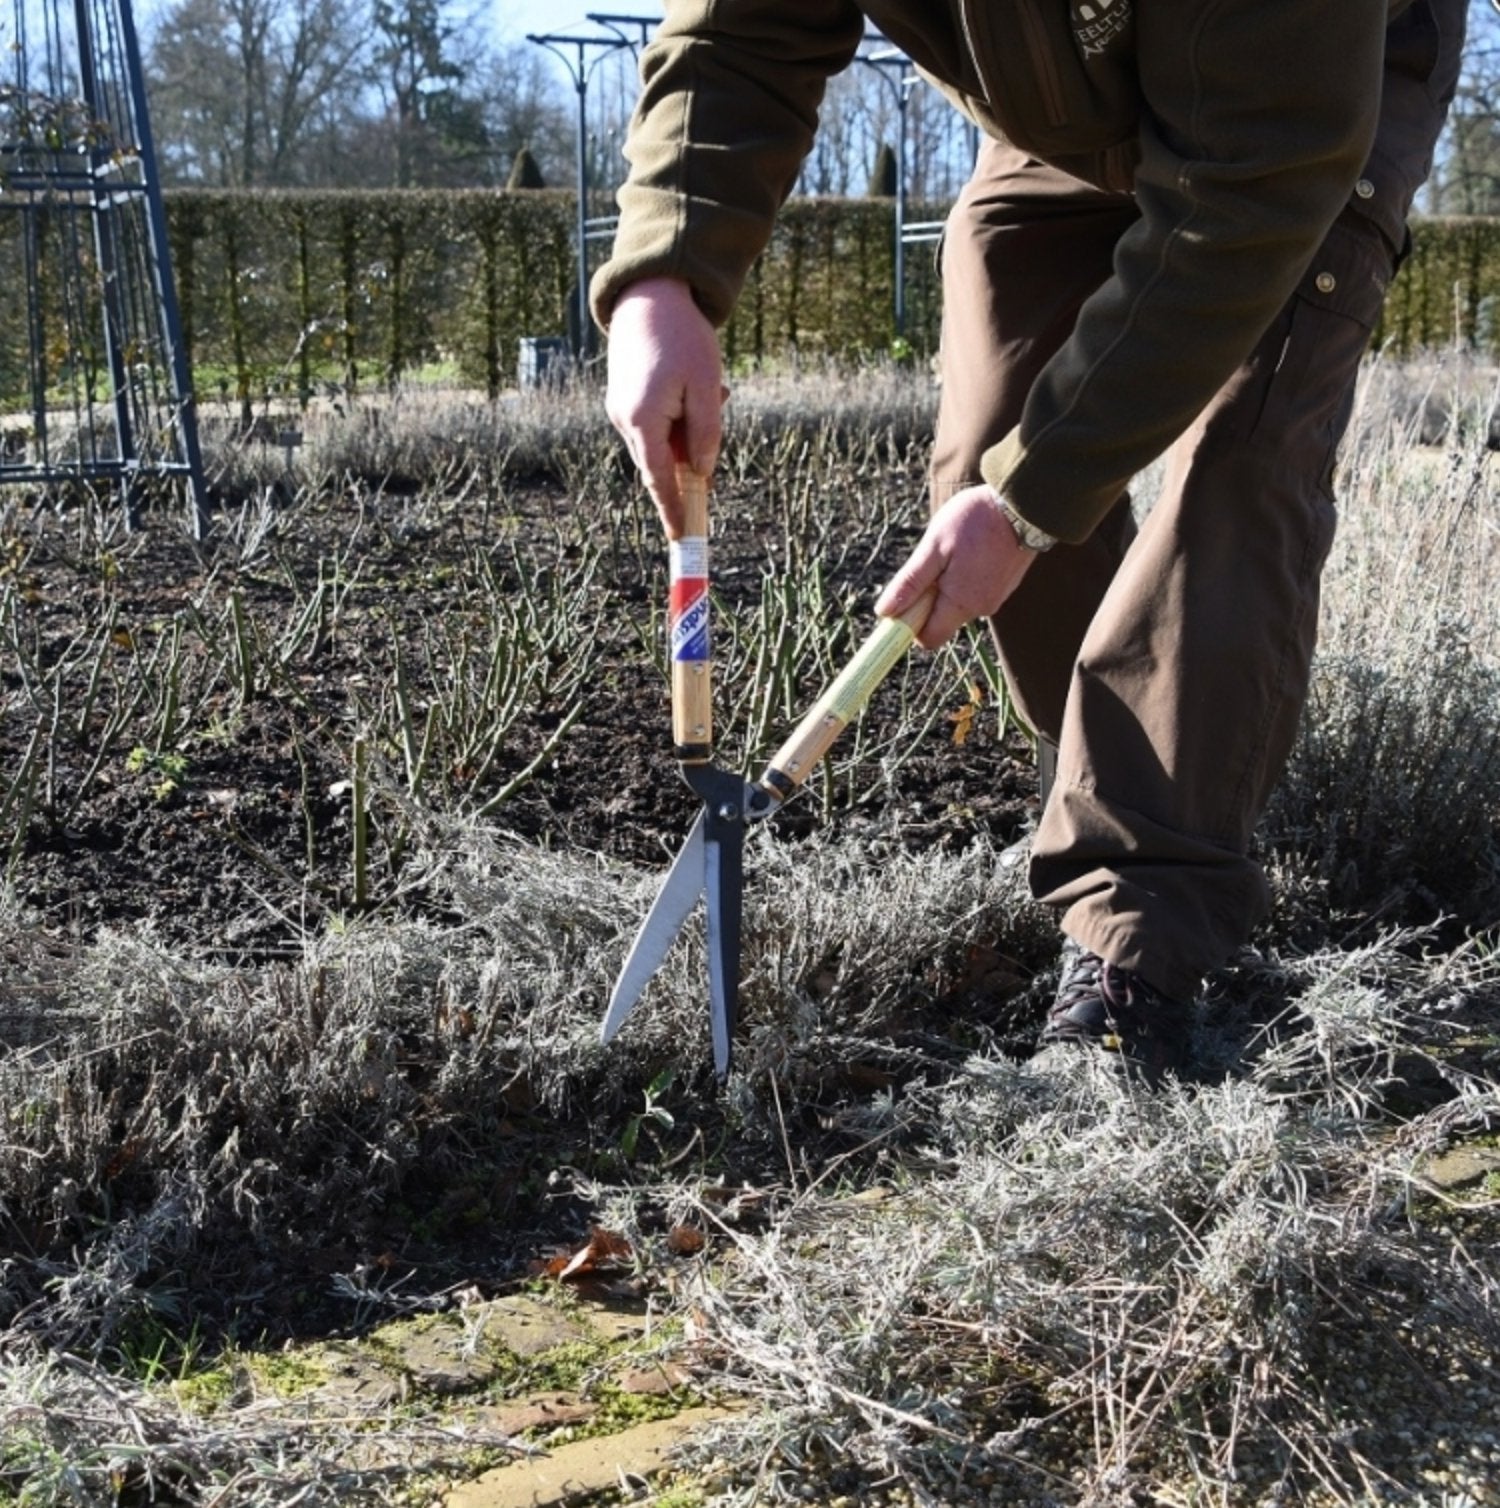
[0,481,1034,961]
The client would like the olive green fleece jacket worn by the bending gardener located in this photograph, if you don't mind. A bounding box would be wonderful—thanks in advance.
[592,0,1408,541]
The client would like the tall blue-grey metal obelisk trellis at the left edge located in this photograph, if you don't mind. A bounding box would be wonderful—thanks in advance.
[0,0,205,531]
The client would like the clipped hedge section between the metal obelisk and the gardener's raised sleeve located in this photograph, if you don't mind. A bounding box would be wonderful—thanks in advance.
[166,190,574,404]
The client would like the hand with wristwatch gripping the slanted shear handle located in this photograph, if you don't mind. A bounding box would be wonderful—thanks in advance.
[874,486,1036,650]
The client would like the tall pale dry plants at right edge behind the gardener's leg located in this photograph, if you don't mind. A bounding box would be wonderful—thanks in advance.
[1268,351,1500,926]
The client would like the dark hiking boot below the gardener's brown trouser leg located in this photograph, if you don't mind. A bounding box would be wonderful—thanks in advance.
[1037,944,1192,1084]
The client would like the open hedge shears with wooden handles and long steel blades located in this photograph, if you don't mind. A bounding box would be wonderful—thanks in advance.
[600,466,933,1080]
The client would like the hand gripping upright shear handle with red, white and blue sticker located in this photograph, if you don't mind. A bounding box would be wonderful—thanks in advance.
[605,277,730,540]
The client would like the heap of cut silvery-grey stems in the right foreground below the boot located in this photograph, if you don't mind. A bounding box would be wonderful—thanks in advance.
[651,922,1500,1503]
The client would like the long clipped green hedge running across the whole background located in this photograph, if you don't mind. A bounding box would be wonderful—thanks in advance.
[0,190,1500,412]
